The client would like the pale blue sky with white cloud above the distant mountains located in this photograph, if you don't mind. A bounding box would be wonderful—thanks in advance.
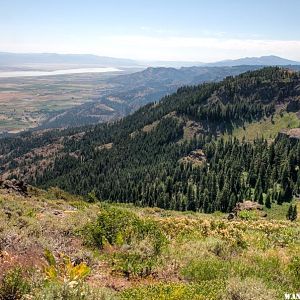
[0,0,300,62]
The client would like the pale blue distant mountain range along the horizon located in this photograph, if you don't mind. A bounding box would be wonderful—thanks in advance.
[0,52,300,68]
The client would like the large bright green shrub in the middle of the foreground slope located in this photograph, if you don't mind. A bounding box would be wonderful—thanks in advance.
[85,207,167,277]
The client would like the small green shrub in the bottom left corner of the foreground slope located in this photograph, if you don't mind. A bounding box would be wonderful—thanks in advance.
[0,267,30,300]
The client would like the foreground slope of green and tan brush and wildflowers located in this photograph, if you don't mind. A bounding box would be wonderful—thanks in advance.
[0,188,300,300]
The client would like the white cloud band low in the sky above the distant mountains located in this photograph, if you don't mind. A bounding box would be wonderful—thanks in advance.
[1,33,300,62]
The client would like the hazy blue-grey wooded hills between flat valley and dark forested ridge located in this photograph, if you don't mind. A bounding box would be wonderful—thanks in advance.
[36,66,274,128]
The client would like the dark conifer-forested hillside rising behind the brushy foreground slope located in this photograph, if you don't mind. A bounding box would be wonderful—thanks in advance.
[0,68,300,213]
